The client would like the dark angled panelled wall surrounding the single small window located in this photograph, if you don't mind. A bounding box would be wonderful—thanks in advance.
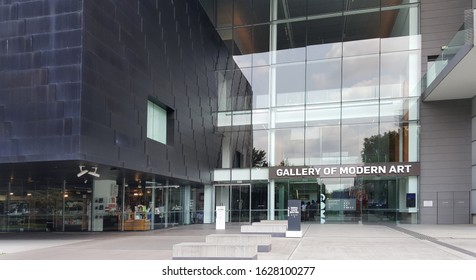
[81,0,223,182]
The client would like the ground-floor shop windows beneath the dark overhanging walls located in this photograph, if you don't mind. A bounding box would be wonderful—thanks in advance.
[0,179,205,232]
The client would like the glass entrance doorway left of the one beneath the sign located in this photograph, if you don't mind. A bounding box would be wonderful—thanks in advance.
[215,184,251,223]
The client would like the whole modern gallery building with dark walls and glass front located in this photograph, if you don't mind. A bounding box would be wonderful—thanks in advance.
[0,0,476,231]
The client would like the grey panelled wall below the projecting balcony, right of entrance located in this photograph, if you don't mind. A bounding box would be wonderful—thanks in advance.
[420,100,471,224]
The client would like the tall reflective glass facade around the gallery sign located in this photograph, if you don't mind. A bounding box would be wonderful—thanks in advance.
[212,0,421,223]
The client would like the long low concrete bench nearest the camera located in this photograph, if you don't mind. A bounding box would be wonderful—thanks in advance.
[172,242,258,260]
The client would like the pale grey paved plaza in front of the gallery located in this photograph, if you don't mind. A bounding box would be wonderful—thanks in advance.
[0,224,476,260]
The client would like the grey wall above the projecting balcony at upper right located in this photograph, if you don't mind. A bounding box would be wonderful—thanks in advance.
[421,0,471,73]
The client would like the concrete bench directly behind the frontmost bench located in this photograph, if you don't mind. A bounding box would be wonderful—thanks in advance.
[205,234,271,252]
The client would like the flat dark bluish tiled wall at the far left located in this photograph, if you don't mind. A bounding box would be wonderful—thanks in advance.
[0,0,82,163]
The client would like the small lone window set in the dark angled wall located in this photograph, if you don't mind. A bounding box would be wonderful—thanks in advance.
[147,100,167,144]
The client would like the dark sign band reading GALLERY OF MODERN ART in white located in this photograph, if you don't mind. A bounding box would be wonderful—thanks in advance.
[269,162,420,179]
